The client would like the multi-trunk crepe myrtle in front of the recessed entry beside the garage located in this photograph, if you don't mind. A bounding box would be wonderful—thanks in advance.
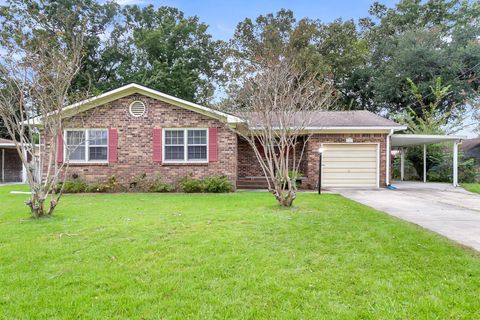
[233,57,335,207]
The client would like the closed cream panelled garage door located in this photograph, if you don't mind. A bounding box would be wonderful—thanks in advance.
[322,143,378,187]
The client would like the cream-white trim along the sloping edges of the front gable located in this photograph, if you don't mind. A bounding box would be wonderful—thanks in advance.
[30,83,244,125]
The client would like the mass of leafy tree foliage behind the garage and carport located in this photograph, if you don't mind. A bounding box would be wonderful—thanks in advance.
[226,0,480,118]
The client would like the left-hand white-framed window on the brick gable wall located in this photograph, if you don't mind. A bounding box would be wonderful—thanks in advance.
[65,129,108,162]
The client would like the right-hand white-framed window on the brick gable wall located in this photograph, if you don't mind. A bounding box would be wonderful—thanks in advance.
[164,129,208,162]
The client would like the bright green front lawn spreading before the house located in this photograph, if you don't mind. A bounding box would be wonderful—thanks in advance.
[0,186,480,319]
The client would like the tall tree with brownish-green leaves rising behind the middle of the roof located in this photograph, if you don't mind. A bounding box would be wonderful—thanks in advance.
[222,9,329,107]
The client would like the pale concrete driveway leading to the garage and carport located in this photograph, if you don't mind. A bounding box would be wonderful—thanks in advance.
[336,182,480,251]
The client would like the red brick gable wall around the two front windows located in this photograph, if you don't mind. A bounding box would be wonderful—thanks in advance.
[46,94,237,185]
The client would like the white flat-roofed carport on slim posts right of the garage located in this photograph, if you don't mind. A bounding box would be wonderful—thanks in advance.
[391,134,465,187]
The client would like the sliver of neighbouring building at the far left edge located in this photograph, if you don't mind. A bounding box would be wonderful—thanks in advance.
[0,138,24,183]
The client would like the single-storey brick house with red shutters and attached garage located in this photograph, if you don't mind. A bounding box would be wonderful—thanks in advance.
[35,84,405,188]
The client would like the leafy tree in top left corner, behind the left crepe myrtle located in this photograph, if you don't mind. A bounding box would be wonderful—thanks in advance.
[0,0,119,95]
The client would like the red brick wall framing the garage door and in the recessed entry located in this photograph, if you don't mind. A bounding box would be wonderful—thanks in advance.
[238,133,387,189]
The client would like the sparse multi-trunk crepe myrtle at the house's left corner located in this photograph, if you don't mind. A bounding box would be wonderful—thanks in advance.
[0,32,83,218]
